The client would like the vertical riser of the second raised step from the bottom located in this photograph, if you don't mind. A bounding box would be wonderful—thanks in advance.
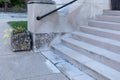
[62,40,120,71]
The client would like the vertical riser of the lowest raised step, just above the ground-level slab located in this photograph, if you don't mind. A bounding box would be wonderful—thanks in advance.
[52,47,110,80]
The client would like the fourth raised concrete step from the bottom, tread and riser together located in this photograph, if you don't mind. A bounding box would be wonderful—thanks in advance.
[80,26,120,41]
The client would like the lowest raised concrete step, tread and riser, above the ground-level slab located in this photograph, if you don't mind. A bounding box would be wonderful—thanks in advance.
[52,44,120,80]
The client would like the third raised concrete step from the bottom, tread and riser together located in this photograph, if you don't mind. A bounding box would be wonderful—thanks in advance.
[72,32,120,54]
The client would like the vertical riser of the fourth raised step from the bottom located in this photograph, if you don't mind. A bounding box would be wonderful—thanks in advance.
[80,27,120,40]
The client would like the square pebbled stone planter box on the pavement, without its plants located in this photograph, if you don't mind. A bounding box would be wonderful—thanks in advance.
[11,31,32,51]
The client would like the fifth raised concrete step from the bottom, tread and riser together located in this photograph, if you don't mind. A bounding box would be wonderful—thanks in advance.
[88,20,120,31]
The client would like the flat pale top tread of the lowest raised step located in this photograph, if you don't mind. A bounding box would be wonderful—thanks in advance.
[53,44,120,80]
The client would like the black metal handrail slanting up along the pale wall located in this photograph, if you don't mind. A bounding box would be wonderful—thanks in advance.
[36,0,77,20]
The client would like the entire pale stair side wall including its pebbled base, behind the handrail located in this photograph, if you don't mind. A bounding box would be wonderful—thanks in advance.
[28,0,110,49]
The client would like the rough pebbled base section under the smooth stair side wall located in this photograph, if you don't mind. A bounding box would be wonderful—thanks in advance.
[34,33,65,50]
